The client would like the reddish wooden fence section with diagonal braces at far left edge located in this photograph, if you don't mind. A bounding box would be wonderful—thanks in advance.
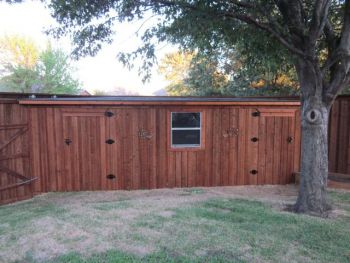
[0,98,34,204]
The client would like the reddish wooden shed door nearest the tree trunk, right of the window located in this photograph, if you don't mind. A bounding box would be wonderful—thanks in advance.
[248,109,296,187]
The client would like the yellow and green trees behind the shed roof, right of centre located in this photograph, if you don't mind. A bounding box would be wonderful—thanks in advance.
[159,51,299,96]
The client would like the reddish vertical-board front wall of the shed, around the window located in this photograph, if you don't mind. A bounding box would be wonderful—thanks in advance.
[29,106,300,193]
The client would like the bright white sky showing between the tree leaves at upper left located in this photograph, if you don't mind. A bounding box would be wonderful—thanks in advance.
[0,1,175,95]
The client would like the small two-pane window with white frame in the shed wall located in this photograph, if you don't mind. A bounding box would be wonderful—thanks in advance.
[171,112,202,148]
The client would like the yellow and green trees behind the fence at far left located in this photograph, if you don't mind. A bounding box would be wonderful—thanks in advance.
[0,36,80,94]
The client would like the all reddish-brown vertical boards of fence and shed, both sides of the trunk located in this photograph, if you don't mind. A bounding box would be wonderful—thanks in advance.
[0,96,350,204]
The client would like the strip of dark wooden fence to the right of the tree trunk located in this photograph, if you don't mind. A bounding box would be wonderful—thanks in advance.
[329,96,350,174]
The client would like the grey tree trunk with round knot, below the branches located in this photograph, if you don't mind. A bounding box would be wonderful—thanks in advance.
[295,96,330,216]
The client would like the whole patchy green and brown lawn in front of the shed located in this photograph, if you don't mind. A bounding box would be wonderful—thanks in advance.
[0,186,350,263]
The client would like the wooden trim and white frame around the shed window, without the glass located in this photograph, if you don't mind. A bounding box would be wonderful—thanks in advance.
[168,109,205,151]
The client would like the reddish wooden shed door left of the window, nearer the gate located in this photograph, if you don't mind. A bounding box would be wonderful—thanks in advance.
[63,112,117,191]
